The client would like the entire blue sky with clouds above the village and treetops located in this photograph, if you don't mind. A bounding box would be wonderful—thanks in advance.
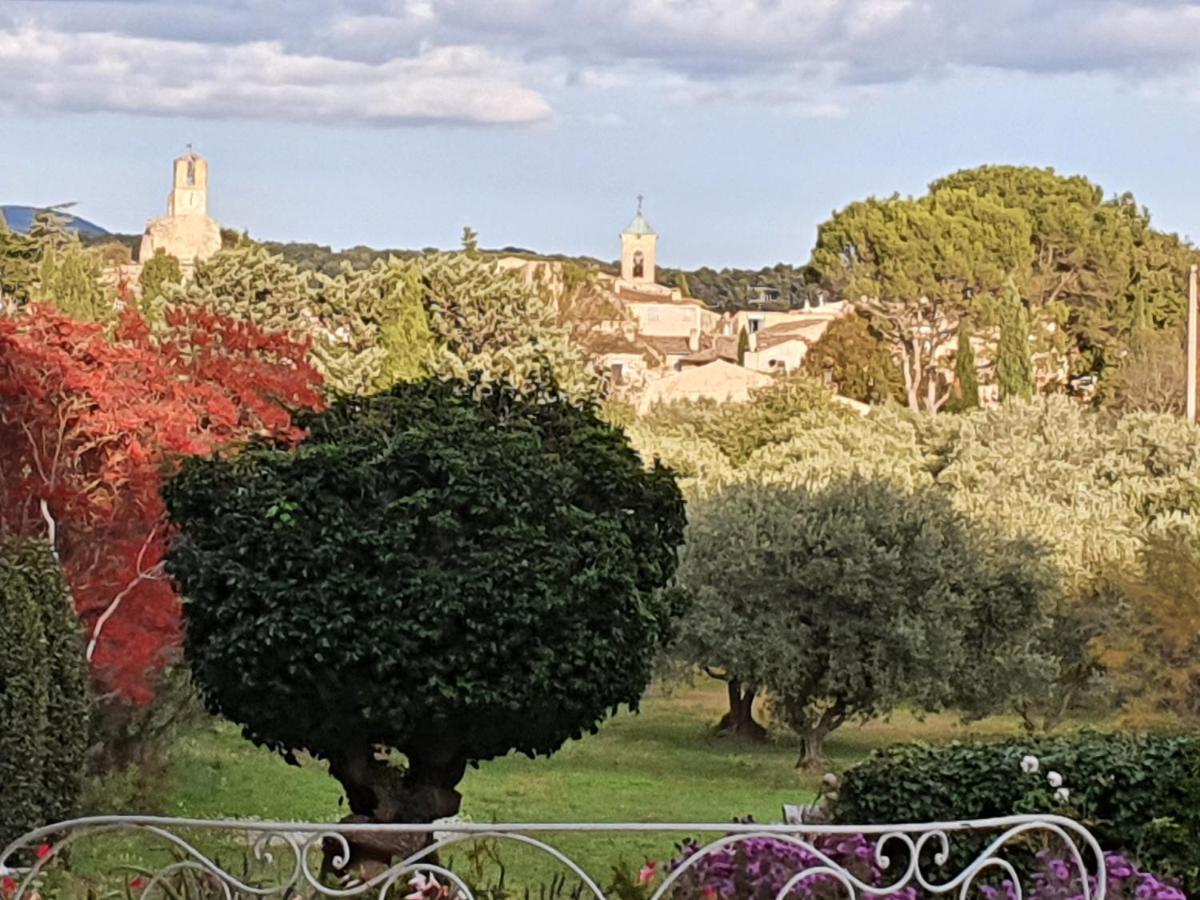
[0,0,1200,268]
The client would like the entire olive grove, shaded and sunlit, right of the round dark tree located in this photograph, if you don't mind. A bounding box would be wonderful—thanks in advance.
[629,378,1200,766]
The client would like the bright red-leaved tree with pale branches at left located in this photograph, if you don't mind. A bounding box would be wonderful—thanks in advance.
[0,306,320,703]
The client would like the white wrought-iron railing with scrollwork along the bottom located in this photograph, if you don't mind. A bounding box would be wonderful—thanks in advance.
[0,815,1106,900]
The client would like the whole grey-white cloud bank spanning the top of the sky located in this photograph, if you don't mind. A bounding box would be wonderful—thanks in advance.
[0,0,1200,122]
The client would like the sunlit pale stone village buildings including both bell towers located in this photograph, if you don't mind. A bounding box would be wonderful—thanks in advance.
[100,148,846,410]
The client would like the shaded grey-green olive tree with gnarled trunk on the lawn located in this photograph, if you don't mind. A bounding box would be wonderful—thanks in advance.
[677,479,1056,768]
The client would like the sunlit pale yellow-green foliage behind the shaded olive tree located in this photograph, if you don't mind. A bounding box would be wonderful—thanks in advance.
[630,385,1200,725]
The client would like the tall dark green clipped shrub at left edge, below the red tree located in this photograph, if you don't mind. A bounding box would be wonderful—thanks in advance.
[0,540,88,847]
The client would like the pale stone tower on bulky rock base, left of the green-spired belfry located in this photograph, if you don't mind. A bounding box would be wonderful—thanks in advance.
[138,145,221,270]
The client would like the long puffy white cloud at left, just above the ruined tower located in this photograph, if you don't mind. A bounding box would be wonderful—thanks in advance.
[0,28,551,125]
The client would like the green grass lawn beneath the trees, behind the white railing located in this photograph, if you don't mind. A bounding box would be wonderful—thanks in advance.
[79,680,1036,880]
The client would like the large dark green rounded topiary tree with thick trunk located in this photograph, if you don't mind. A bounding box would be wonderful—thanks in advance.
[166,380,684,821]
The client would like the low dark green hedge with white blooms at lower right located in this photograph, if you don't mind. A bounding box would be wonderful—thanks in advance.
[835,733,1200,894]
